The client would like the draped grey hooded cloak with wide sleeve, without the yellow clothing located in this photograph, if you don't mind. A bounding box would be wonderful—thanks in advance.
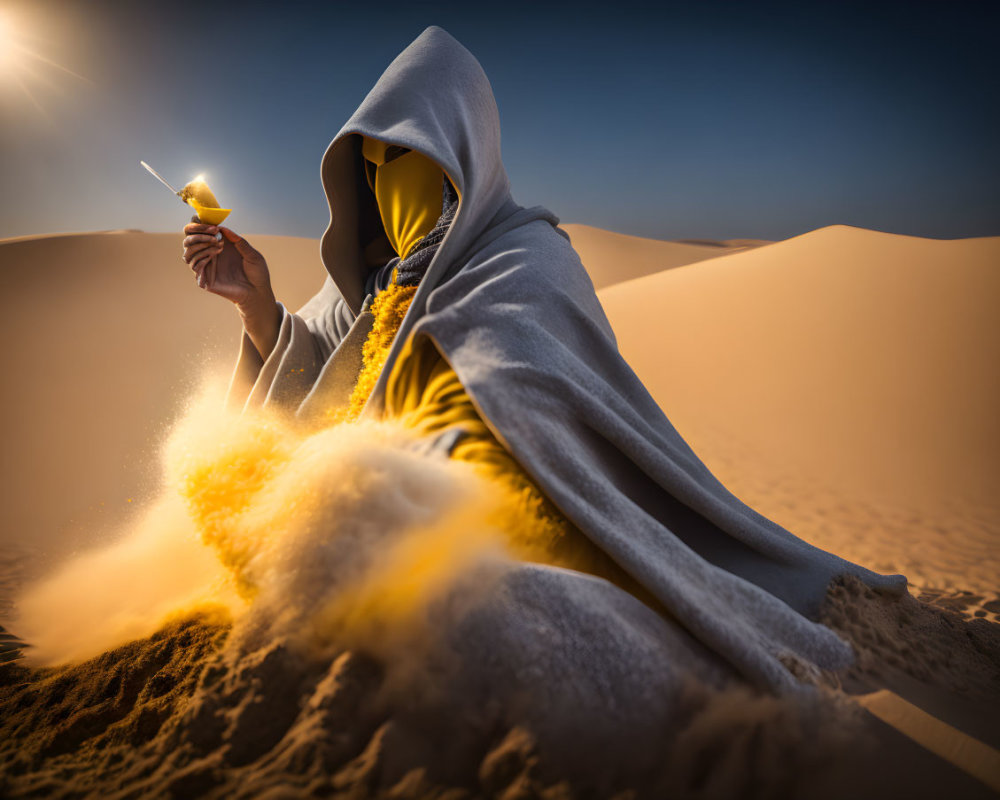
[230,27,906,690]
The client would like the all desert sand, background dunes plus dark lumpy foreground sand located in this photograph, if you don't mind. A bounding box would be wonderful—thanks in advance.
[0,225,1000,798]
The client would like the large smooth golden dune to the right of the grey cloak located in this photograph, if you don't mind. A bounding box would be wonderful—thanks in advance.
[600,226,1000,613]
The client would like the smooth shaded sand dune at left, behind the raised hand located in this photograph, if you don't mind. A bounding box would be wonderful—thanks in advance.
[0,232,325,548]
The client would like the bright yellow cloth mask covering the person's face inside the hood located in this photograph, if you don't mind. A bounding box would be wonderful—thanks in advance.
[361,137,444,258]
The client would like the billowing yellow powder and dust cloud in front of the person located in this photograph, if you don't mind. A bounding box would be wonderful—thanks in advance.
[16,378,539,663]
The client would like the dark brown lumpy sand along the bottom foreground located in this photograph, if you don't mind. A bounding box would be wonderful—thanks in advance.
[0,585,1000,800]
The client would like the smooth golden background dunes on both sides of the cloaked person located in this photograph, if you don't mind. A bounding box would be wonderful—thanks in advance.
[0,225,1000,605]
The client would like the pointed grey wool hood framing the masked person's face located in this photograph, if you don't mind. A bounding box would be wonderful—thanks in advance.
[321,26,519,313]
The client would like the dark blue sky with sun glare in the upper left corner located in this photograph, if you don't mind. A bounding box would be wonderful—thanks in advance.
[0,0,1000,239]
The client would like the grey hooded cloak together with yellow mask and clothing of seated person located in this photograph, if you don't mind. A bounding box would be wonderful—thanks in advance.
[228,27,906,691]
